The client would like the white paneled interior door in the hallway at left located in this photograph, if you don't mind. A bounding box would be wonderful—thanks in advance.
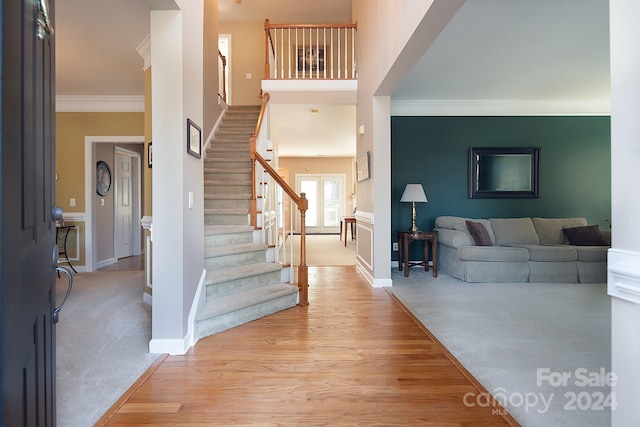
[115,150,135,259]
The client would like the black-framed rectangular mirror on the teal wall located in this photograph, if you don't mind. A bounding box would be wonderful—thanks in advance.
[469,147,540,199]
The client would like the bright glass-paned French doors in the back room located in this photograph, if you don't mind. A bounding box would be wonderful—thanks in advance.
[296,174,345,233]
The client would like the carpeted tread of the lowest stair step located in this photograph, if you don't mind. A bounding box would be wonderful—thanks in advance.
[196,283,298,321]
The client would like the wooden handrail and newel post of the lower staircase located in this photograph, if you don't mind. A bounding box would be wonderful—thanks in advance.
[249,92,309,306]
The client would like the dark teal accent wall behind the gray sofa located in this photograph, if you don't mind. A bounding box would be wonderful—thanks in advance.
[391,116,611,259]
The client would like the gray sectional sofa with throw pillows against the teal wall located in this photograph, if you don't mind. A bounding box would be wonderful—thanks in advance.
[435,216,611,283]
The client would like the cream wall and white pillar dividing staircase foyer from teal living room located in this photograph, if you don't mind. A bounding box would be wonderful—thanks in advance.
[353,0,464,286]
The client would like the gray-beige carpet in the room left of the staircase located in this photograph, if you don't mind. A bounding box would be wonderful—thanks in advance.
[56,271,159,427]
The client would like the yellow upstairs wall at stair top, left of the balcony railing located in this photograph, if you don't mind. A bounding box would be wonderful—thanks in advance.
[219,22,265,105]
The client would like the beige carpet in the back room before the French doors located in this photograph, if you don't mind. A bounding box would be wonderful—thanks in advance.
[287,234,356,266]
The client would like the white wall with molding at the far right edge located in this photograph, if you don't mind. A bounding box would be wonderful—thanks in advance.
[608,0,640,427]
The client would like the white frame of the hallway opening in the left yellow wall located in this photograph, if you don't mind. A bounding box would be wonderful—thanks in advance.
[84,135,144,272]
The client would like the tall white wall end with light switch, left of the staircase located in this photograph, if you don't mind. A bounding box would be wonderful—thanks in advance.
[149,0,205,354]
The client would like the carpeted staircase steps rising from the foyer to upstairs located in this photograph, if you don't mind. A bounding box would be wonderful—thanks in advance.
[195,106,298,339]
